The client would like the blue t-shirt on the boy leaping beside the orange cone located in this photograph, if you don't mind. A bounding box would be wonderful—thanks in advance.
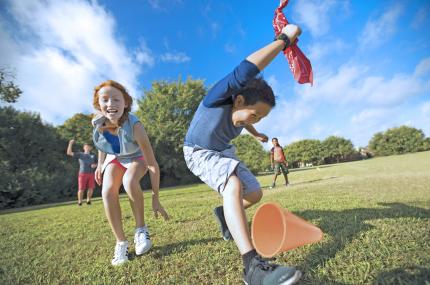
[184,60,260,151]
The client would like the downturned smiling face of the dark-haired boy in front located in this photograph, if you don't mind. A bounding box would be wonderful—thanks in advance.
[231,95,272,127]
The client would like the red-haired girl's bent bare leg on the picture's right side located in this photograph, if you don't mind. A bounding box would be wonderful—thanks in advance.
[122,160,148,228]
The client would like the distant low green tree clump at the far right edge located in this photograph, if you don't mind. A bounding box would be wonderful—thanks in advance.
[369,126,426,156]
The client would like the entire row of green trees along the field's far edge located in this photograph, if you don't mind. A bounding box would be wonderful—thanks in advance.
[0,70,430,209]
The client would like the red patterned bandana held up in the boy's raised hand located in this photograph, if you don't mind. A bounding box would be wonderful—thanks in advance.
[272,0,313,85]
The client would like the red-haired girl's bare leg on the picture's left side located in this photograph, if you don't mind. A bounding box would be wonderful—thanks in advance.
[102,163,126,242]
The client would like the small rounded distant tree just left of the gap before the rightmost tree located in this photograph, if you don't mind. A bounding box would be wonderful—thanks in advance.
[322,136,355,162]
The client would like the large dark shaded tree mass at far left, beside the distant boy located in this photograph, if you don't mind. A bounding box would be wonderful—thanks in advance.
[0,107,77,208]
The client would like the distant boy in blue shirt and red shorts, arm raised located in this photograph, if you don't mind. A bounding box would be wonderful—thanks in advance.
[67,140,97,206]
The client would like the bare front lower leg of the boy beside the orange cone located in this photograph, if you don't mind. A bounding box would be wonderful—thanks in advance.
[223,174,254,255]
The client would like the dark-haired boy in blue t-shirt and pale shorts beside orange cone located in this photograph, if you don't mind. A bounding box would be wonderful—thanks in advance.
[184,25,301,285]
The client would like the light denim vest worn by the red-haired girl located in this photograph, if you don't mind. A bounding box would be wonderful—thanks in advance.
[92,113,143,158]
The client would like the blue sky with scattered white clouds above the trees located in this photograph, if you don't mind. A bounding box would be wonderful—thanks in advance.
[0,0,430,146]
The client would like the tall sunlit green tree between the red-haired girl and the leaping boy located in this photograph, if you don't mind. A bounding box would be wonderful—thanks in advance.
[136,78,206,185]
